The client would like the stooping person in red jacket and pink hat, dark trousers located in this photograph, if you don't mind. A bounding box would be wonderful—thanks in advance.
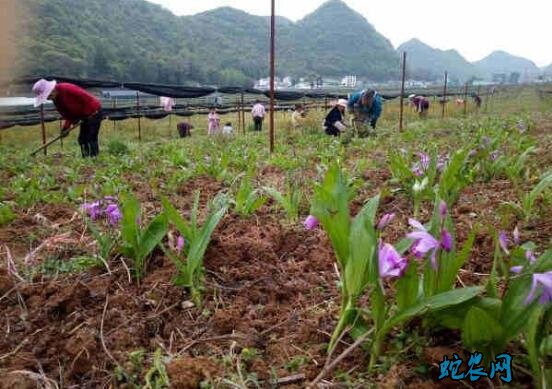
[33,79,103,158]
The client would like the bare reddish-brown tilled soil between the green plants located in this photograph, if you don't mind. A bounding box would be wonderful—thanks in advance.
[0,140,552,388]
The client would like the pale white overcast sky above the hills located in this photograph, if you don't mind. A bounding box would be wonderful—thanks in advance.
[149,0,552,66]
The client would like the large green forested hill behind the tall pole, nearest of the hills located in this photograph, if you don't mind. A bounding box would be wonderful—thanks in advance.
[12,0,399,85]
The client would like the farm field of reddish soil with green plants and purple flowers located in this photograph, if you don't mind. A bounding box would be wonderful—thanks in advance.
[0,88,552,388]
